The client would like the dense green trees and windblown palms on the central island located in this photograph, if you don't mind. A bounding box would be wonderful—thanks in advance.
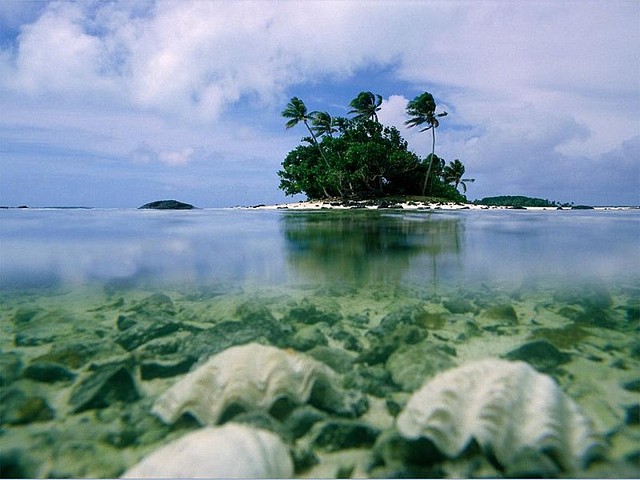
[278,92,473,202]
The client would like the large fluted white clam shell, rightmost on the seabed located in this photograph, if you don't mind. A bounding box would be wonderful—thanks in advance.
[397,359,604,470]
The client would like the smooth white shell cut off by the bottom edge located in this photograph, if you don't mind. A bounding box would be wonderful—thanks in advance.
[122,423,293,478]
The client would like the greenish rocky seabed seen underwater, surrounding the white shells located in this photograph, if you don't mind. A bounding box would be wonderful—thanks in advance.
[0,285,640,478]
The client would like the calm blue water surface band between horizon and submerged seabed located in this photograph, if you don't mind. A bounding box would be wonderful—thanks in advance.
[0,209,640,290]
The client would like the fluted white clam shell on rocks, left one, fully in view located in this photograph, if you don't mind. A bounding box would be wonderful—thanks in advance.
[152,343,334,425]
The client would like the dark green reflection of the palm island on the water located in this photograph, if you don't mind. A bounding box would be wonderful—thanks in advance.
[283,211,463,285]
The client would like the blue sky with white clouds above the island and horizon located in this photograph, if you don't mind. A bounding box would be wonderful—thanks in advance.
[0,0,640,208]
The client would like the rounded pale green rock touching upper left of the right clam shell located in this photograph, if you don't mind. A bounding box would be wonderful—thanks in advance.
[386,341,455,392]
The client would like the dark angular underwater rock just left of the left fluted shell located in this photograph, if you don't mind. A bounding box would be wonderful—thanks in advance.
[69,362,140,413]
